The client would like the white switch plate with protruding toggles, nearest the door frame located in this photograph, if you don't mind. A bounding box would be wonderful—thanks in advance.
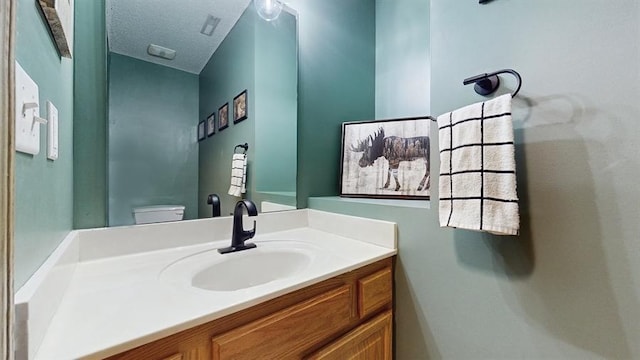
[15,62,40,155]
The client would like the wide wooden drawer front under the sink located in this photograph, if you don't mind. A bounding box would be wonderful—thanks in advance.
[212,285,353,360]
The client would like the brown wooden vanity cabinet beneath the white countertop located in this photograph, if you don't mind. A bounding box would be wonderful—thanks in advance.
[109,258,393,360]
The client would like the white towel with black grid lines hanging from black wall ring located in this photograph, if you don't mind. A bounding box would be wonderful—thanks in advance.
[438,94,520,235]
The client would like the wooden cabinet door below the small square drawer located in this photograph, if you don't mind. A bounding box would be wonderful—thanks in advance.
[307,310,392,360]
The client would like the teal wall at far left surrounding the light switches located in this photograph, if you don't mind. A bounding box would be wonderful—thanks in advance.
[14,0,73,289]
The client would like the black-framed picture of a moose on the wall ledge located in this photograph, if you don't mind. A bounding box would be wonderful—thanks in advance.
[340,118,431,200]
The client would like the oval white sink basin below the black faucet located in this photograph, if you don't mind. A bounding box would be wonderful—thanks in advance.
[160,240,324,292]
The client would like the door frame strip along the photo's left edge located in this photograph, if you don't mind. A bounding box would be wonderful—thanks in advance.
[0,0,17,360]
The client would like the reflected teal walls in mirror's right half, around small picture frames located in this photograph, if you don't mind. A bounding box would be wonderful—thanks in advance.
[198,8,298,217]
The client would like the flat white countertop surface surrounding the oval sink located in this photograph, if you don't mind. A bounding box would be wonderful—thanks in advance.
[28,212,396,360]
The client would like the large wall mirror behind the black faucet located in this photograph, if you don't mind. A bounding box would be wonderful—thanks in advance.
[106,0,298,226]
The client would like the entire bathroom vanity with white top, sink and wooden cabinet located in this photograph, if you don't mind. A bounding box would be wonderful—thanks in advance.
[16,209,396,360]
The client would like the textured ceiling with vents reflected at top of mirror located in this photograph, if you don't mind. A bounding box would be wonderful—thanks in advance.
[106,0,251,74]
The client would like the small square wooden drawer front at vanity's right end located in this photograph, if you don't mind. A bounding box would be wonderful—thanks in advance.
[358,268,393,318]
